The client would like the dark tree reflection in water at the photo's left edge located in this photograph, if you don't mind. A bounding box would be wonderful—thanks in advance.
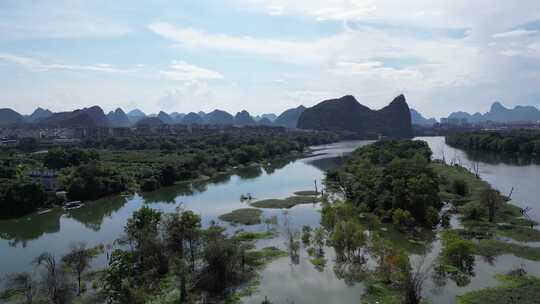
[0,209,62,248]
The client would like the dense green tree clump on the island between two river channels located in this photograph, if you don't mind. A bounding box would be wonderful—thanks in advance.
[326,140,442,228]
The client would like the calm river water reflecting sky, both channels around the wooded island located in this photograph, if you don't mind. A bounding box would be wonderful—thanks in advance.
[0,137,540,303]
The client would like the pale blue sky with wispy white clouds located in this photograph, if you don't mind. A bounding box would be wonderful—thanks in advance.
[0,0,540,117]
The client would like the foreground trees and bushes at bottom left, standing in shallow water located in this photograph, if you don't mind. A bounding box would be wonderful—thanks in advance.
[0,207,285,304]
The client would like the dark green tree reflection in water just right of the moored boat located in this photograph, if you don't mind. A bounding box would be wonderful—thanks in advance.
[68,196,127,231]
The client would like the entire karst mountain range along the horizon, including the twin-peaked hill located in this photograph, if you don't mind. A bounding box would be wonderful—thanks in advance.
[4,96,540,130]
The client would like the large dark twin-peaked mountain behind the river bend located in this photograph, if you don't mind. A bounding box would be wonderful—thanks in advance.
[298,95,412,137]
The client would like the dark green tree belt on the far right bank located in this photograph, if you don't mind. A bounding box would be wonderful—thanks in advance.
[446,130,540,155]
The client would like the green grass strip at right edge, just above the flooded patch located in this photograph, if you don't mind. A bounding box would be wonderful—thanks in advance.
[476,240,540,261]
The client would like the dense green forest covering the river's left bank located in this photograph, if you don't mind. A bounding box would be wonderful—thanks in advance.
[0,128,338,217]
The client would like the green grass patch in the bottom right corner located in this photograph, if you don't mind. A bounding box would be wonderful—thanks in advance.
[457,275,540,304]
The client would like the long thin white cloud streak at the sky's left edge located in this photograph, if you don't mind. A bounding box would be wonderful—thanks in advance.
[0,53,136,73]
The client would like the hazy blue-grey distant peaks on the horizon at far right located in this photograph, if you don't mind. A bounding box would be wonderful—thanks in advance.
[448,102,540,123]
